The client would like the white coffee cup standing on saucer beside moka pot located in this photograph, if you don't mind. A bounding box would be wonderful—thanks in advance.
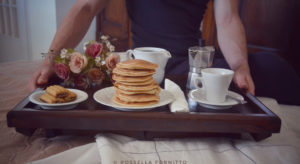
[194,68,234,103]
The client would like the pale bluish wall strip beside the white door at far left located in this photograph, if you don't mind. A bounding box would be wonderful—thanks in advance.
[25,0,56,60]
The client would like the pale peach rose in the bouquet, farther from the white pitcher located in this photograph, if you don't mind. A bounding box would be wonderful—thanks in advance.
[69,52,88,73]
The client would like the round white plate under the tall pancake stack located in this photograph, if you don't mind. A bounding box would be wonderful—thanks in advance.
[94,87,174,111]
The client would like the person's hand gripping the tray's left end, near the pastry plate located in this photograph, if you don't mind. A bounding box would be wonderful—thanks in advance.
[28,59,54,92]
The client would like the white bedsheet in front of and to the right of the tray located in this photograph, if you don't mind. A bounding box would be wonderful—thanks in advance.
[32,98,300,164]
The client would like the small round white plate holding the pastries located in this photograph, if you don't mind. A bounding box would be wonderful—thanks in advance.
[29,88,88,110]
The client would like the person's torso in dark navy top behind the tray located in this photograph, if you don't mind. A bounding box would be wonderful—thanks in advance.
[126,0,208,54]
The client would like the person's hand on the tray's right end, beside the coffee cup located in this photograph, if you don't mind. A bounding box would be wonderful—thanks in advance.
[233,64,255,95]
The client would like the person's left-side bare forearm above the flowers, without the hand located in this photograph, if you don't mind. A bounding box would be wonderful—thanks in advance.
[49,0,106,60]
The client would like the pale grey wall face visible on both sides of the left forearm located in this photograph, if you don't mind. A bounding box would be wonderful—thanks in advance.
[56,0,96,52]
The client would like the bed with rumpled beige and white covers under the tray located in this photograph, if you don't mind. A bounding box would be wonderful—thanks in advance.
[0,61,300,164]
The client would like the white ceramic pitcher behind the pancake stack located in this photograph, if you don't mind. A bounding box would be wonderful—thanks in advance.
[126,47,172,84]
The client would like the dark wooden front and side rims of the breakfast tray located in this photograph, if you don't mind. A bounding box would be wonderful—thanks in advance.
[7,76,281,140]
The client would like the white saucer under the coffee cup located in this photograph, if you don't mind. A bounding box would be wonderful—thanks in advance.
[188,88,244,109]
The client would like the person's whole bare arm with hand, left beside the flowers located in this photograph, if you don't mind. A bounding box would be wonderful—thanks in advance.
[28,0,107,91]
